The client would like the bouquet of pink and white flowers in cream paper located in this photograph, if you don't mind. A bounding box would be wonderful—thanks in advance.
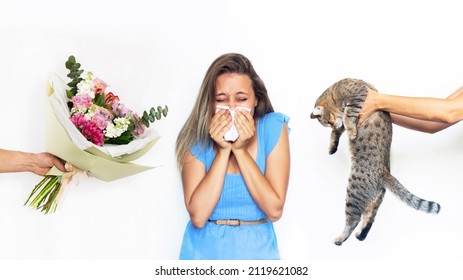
[24,56,168,214]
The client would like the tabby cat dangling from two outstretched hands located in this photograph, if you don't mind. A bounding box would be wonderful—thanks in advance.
[310,78,440,245]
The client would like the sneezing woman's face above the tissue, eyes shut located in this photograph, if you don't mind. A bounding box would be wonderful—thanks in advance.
[213,73,257,116]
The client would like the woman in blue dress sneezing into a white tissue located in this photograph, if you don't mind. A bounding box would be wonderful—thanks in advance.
[176,53,290,259]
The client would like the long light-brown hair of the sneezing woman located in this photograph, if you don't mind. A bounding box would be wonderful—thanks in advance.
[175,53,274,170]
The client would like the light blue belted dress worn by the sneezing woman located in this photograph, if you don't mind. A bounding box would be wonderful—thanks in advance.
[180,113,289,260]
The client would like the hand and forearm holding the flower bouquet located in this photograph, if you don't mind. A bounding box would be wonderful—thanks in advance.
[0,149,65,176]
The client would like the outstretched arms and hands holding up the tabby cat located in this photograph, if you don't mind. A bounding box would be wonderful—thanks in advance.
[359,87,463,133]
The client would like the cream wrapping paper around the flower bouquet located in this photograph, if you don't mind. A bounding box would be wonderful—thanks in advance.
[45,74,160,182]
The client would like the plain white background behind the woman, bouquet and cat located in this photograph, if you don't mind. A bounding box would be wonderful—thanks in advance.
[0,0,463,278]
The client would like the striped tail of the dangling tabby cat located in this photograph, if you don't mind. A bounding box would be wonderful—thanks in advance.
[384,174,440,214]
